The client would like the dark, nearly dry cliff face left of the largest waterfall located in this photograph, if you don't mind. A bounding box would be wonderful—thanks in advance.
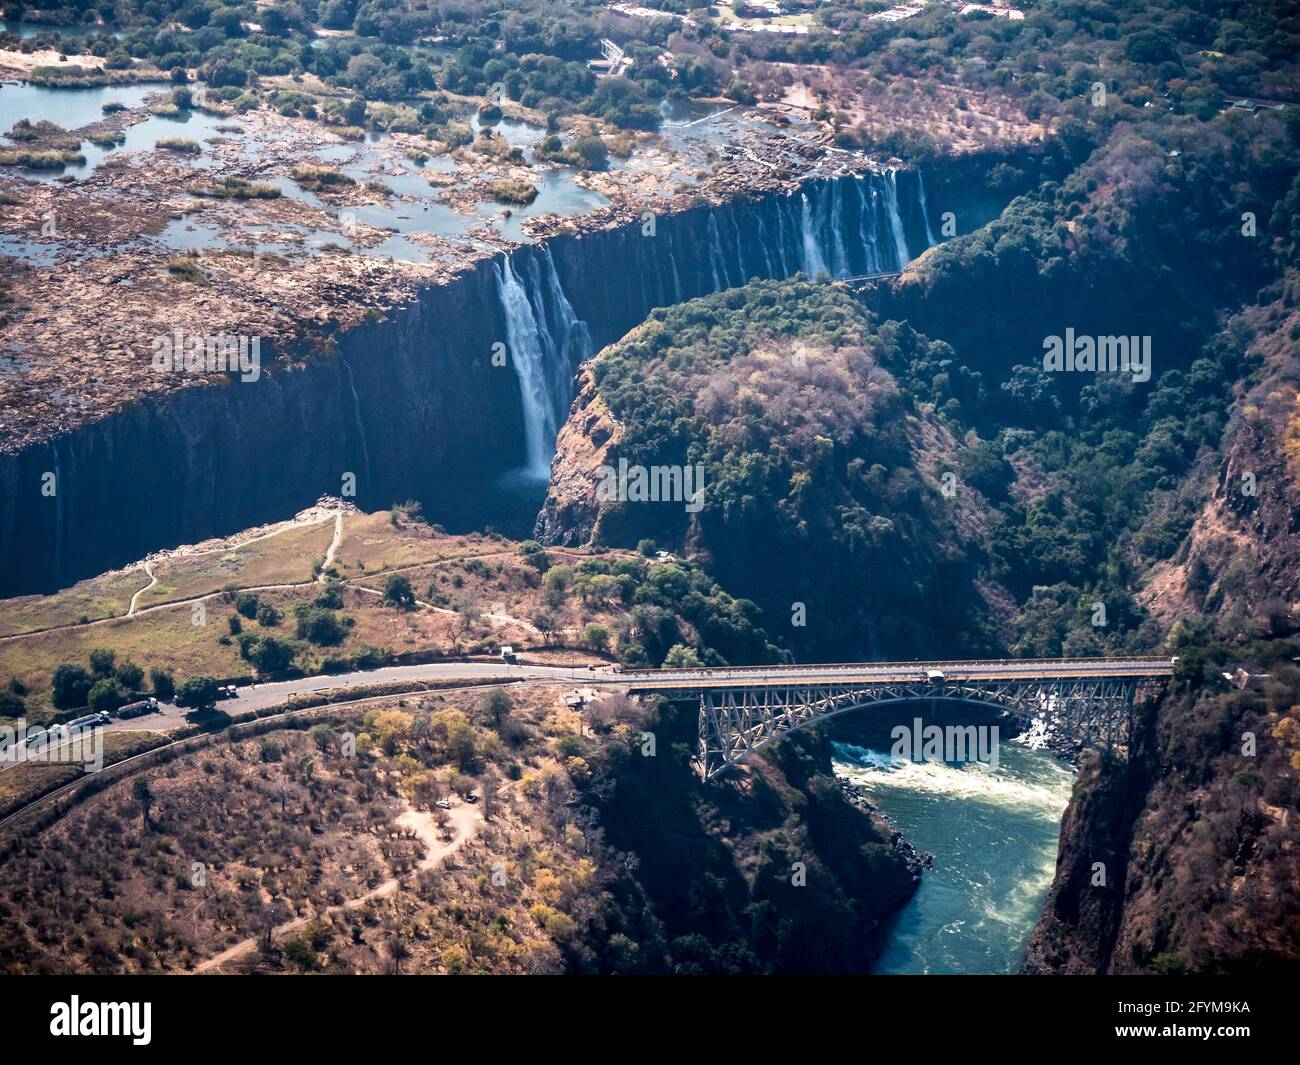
[0,257,520,596]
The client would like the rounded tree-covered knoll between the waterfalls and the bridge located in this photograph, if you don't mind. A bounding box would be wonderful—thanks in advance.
[538,280,998,657]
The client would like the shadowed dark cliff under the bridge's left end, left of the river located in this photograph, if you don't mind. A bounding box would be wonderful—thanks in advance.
[601,703,920,973]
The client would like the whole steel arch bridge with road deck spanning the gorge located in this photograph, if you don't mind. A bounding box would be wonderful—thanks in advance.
[621,658,1175,780]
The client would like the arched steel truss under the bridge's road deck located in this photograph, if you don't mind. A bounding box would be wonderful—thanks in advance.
[696,675,1162,780]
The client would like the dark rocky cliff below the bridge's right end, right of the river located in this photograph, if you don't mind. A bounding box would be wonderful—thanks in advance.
[1024,661,1300,974]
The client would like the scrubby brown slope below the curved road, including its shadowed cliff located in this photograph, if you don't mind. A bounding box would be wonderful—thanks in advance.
[0,689,918,974]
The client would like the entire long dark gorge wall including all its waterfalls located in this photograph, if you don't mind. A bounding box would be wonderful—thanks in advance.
[0,150,1034,596]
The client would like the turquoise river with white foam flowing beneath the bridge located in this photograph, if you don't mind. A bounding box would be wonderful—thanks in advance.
[835,744,1074,974]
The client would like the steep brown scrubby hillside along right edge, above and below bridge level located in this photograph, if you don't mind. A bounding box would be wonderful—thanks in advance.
[1026,273,1300,973]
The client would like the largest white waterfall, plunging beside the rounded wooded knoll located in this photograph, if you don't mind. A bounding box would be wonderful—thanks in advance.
[494,244,592,477]
